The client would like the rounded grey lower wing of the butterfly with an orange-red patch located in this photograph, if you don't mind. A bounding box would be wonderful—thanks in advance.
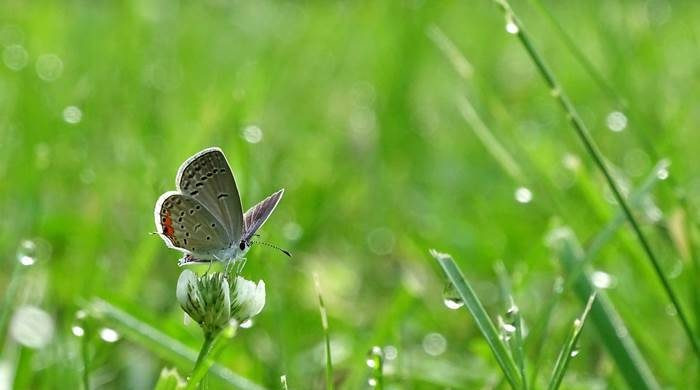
[154,191,228,260]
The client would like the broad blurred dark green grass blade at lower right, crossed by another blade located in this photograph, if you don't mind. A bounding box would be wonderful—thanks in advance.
[549,227,660,389]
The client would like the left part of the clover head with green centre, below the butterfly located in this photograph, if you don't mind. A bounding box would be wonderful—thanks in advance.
[176,270,231,333]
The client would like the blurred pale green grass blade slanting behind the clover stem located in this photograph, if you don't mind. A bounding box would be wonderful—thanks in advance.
[87,298,263,390]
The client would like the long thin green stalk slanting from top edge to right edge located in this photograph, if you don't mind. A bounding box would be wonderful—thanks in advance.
[494,0,700,357]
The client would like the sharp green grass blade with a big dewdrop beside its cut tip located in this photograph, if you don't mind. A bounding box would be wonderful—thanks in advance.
[430,250,522,389]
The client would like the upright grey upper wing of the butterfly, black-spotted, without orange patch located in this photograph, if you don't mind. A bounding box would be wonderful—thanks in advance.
[176,148,245,245]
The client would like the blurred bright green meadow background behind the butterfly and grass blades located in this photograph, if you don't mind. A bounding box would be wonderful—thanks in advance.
[0,0,700,389]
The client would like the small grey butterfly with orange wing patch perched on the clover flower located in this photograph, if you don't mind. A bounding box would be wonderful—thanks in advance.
[153,147,284,265]
